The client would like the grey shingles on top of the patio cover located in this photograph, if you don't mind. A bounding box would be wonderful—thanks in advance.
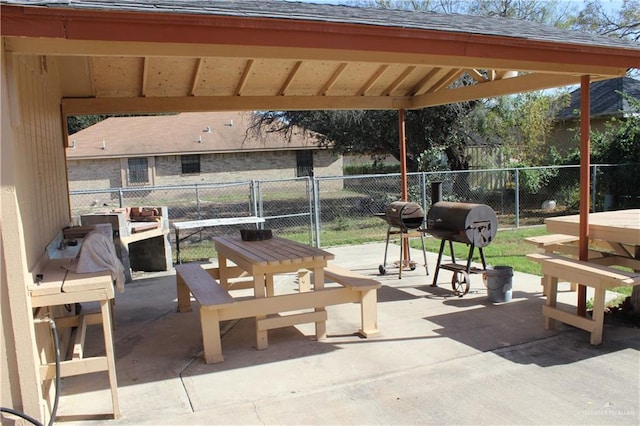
[2,0,637,48]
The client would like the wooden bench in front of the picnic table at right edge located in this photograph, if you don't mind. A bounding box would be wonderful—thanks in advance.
[527,253,640,345]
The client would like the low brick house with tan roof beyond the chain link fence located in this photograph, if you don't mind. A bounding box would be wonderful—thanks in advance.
[66,112,342,190]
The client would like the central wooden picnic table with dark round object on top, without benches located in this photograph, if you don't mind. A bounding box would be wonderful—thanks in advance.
[213,237,334,349]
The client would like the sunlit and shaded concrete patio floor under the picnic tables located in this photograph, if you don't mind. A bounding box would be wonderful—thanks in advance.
[52,244,640,425]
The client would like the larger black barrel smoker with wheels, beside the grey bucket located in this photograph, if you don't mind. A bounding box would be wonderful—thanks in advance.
[427,201,498,297]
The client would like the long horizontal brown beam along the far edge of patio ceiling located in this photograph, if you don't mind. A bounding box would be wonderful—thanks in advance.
[62,96,410,115]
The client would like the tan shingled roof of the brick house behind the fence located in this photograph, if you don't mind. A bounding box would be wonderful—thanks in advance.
[67,112,320,160]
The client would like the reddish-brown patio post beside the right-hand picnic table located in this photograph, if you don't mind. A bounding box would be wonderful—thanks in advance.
[578,75,591,317]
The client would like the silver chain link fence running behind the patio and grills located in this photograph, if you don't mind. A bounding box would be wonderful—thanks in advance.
[70,164,640,260]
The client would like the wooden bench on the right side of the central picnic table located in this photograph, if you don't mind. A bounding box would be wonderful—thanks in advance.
[298,263,382,337]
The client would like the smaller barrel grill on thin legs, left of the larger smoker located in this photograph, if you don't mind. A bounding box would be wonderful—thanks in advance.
[378,201,429,279]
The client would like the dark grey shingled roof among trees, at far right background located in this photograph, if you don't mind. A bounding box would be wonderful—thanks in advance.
[556,77,640,120]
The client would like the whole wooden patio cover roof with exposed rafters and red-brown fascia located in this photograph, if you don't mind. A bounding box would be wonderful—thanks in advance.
[2,0,640,121]
